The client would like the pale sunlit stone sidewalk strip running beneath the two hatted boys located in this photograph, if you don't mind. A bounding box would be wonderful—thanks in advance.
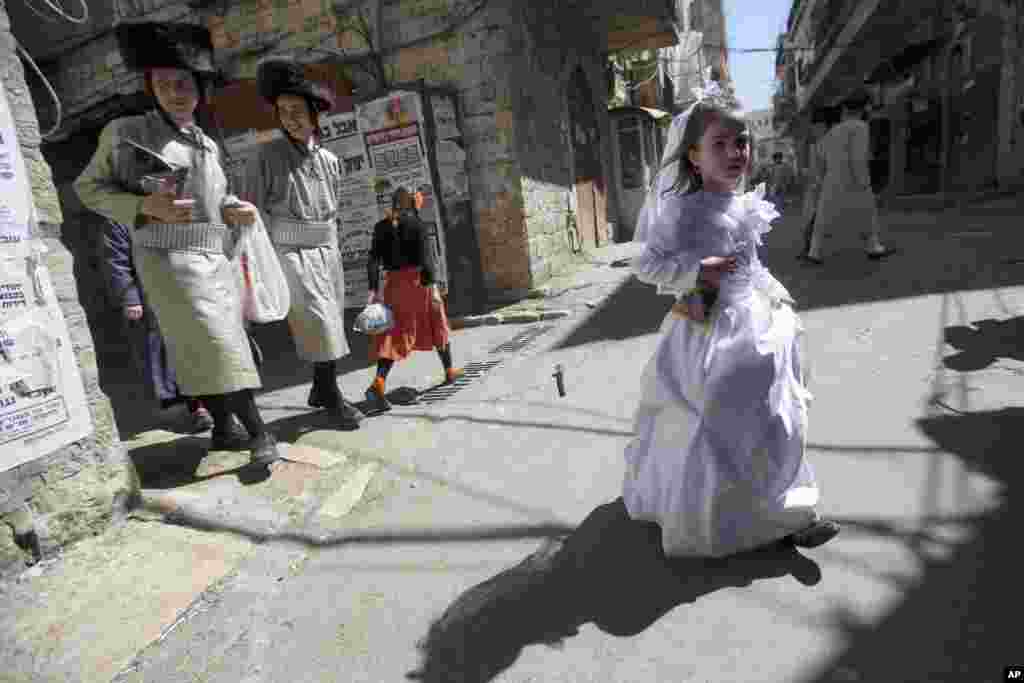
[0,241,628,683]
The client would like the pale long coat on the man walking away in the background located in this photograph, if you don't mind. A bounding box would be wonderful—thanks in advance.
[814,119,879,250]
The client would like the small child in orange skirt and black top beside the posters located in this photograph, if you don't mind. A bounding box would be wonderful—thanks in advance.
[367,187,464,411]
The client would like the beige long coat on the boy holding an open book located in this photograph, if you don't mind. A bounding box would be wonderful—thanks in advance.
[75,112,260,396]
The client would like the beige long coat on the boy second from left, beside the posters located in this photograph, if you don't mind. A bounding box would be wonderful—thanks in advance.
[246,137,349,362]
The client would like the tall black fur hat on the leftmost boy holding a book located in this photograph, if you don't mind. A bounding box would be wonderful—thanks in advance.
[115,22,219,78]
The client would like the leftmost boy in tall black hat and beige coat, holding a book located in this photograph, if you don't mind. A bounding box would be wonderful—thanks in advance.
[75,23,279,465]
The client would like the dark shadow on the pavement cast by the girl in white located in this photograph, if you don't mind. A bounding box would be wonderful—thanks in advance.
[407,499,821,683]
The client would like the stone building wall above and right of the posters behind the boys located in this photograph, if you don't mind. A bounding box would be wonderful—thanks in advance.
[34,0,647,313]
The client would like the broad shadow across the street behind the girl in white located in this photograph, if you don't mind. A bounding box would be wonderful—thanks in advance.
[557,207,1024,348]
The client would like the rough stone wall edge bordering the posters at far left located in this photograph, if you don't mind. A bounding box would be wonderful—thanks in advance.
[0,0,138,575]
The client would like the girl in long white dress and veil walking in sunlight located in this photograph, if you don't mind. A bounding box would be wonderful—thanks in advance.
[624,93,839,557]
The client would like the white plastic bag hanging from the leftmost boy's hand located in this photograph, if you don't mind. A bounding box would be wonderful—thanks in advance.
[233,214,292,323]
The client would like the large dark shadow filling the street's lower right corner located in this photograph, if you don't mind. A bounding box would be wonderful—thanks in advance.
[813,408,1024,683]
